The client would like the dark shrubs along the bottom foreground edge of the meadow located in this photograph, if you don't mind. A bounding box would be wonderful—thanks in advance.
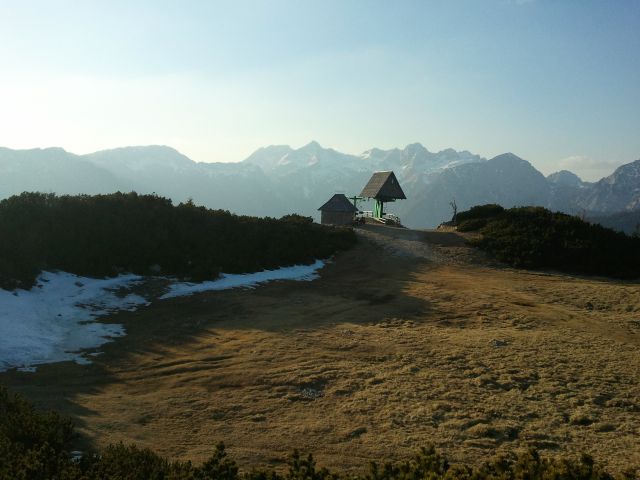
[0,387,636,480]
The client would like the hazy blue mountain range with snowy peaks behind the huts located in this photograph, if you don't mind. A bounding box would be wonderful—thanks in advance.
[0,142,640,232]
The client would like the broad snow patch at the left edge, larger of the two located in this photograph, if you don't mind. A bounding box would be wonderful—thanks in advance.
[0,272,148,372]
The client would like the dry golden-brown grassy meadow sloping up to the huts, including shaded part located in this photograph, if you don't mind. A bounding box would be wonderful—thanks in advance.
[0,227,640,472]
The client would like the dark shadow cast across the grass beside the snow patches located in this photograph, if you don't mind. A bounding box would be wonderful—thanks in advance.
[0,241,430,451]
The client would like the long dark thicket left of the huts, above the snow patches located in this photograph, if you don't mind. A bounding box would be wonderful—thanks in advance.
[0,193,356,288]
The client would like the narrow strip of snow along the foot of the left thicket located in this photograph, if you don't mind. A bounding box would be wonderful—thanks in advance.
[160,260,324,299]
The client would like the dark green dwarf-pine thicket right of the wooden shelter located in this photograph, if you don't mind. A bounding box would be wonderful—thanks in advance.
[457,205,640,278]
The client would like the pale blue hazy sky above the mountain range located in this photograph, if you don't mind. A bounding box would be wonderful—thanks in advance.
[0,0,640,179]
